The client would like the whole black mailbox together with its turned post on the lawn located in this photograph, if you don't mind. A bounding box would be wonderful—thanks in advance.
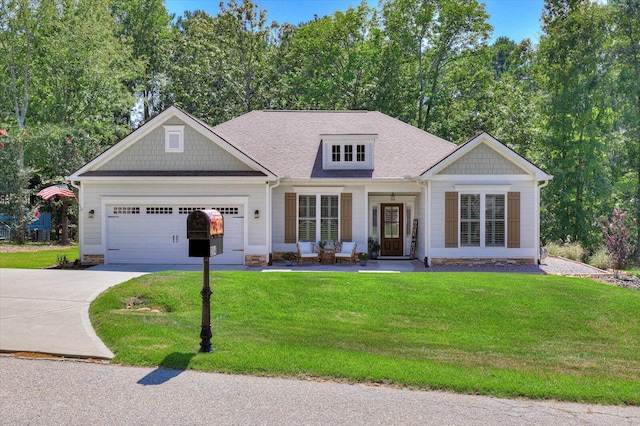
[187,210,224,352]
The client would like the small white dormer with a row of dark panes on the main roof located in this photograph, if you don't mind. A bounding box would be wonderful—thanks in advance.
[321,135,378,170]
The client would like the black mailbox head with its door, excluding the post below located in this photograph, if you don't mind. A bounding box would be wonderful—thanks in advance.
[187,210,224,257]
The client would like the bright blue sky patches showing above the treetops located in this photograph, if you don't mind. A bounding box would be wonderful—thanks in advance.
[166,0,544,43]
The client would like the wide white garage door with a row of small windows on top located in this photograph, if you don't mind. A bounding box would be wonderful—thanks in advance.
[106,205,244,265]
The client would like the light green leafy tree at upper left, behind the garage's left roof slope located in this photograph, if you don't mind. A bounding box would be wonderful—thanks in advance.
[30,0,140,131]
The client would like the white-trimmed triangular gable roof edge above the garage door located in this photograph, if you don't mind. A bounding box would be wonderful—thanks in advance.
[67,106,274,181]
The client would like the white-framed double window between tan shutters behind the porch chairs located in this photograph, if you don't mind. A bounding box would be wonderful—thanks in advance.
[298,194,340,241]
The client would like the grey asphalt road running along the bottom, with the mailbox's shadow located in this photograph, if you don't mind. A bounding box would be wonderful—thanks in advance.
[0,356,640,426]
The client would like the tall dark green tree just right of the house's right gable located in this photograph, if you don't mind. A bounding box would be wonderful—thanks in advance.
[537,0,615,248]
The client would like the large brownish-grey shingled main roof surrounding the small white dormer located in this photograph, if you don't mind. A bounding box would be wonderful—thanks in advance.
[212,110,456,179]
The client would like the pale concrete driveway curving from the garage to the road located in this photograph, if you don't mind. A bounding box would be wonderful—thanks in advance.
[0,269,144,359]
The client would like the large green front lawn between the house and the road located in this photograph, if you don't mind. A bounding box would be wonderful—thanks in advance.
[90,272,640,405]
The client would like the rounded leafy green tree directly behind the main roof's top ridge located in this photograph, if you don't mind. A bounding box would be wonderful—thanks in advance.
[283,2,381,109]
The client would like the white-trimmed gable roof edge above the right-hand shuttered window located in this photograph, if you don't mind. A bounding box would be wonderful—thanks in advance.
[420,132,553,181]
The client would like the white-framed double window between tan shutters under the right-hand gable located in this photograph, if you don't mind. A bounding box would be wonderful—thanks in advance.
[459,193,506,247]
